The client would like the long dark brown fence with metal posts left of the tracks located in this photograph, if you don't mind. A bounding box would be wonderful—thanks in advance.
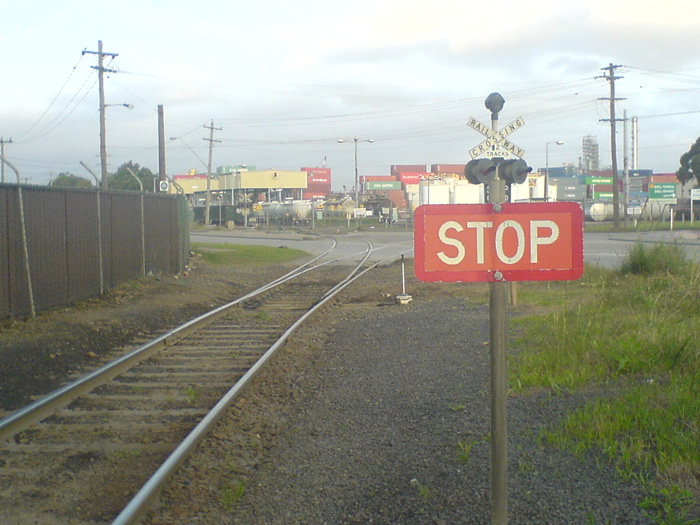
[0,184,189,319]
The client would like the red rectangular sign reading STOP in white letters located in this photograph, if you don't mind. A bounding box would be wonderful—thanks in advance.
[414,202,583,282]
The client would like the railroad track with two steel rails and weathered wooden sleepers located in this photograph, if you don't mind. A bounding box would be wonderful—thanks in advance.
[0,238,394,524]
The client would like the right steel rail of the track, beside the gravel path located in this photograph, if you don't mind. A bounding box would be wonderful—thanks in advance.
[112,240,380,525]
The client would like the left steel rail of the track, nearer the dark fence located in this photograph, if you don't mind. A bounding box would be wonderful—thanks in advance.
[0,241,337,440]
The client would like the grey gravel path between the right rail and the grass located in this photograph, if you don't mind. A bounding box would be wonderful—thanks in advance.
[153,292,652,524]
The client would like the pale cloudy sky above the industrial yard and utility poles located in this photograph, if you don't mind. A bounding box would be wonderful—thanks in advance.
[0,0,700,190]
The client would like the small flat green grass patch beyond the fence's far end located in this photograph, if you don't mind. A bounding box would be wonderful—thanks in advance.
[192,243,308,267]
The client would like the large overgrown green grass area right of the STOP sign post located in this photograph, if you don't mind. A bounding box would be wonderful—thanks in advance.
[509,245,700,523]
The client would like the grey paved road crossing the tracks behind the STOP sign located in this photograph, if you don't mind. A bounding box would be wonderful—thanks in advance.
[190,229,700,268]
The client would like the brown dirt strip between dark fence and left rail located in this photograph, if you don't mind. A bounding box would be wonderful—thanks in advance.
[0,255,287,416]
